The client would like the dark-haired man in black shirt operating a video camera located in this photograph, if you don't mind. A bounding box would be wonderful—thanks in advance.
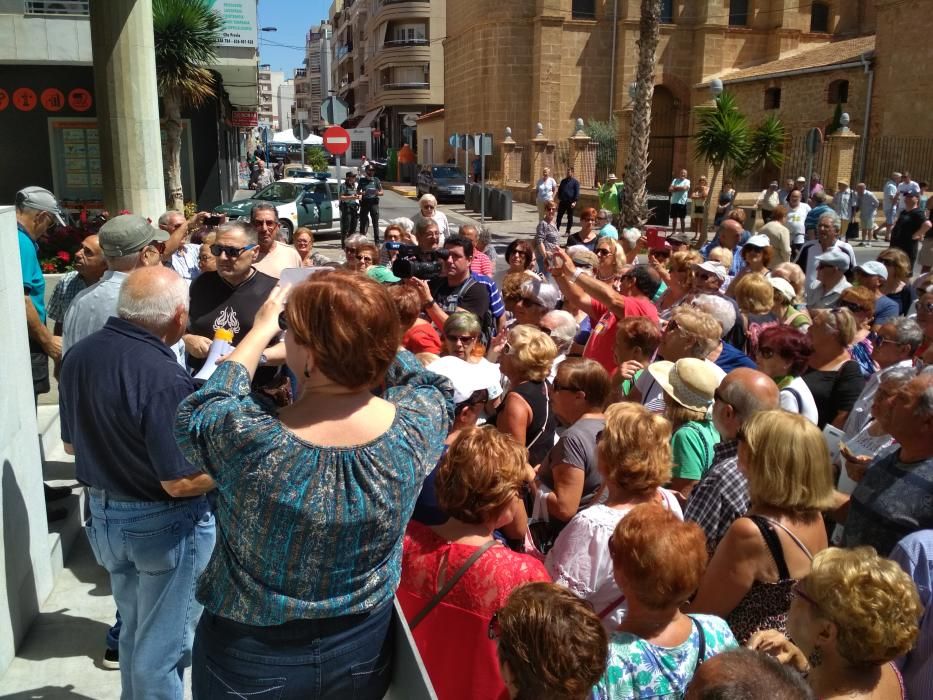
[407,235,489,328]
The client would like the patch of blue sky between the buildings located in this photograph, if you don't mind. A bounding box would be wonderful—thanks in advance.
[259,0,331,78]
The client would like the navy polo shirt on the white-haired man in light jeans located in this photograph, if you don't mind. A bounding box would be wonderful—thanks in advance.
[58,316,199,501]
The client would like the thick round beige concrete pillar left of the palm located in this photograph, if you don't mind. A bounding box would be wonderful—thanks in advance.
[91,0,165,221]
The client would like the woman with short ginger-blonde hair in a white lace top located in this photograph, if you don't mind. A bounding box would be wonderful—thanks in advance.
[545,403,683,630]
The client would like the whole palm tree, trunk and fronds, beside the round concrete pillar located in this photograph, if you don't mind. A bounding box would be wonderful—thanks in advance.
[152,0,223,211]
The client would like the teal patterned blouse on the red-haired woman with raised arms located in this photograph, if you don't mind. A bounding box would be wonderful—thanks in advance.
[175,350,453,626]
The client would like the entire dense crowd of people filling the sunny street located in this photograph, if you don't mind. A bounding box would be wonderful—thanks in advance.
[16,172,933,700]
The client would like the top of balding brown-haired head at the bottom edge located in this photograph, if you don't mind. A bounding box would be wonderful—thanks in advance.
[684,649,815,700]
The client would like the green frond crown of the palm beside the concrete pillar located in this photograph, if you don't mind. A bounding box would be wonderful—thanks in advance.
[152,0,223,106]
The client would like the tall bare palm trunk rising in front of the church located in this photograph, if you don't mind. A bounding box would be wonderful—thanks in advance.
[621,0,661,227]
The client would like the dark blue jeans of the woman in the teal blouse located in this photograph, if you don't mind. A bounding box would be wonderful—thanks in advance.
[191,601,394,700]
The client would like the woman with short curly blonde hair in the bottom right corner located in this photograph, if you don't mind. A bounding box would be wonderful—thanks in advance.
[748,547,923,700]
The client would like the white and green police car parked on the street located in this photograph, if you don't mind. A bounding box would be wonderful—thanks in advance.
[214,173,340,243]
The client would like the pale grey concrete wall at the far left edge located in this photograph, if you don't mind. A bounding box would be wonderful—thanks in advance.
[0,207,52,675]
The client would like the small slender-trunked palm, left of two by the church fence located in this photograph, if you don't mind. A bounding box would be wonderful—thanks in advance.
[694,92,748,246]
